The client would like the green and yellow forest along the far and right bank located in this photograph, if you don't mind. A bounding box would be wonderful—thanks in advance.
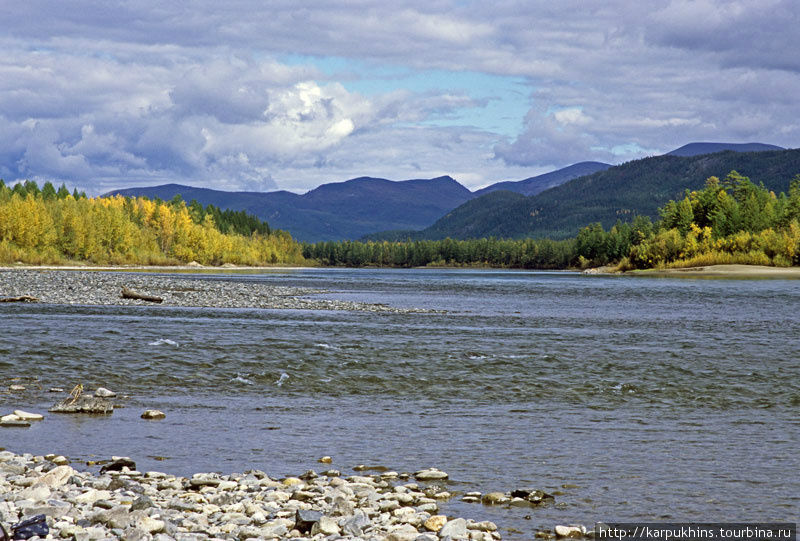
[303,171,800,270]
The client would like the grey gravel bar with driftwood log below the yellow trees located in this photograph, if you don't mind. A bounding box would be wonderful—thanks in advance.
[0,267,432,313]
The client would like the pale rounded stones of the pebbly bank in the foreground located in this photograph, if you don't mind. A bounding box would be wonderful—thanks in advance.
[0,451,510,541]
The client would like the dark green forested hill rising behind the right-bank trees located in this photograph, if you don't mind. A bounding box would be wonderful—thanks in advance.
[409,149,800,239]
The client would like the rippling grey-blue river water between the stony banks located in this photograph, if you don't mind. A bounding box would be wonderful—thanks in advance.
[0,269,800,539]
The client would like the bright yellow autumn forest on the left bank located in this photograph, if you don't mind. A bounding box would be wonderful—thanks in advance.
[0,180,304,266]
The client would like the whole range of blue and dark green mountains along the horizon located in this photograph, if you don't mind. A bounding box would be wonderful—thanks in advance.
[106,143,800,242]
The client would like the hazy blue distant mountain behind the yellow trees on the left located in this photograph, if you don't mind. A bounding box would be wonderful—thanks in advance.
[111,176,473,242]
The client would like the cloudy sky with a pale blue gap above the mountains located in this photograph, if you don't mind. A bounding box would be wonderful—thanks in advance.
[0,0,800,195]
